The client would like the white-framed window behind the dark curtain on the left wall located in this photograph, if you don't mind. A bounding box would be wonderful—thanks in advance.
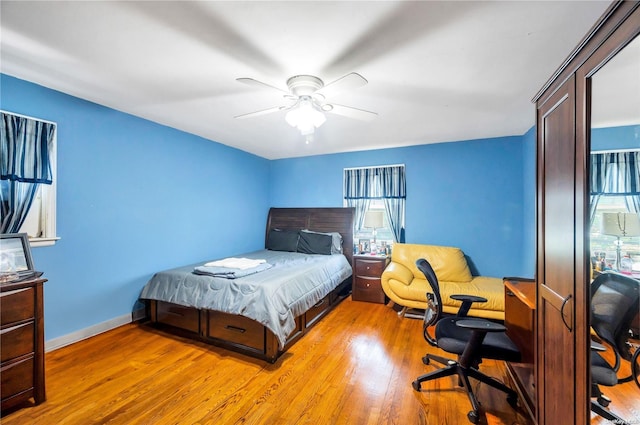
[0,111,59,247]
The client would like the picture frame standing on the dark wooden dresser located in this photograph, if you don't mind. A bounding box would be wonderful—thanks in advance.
[0,233,35,282]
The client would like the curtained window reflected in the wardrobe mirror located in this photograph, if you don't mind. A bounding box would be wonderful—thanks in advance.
[589,151,640,273]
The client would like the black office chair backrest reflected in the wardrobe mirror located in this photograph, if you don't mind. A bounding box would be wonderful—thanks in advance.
[591,273,640,363]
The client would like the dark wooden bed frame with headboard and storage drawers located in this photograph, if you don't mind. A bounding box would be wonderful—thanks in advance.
[147,208,354,363]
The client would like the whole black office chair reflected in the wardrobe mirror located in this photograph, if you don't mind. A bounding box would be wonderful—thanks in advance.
[591,272,640,424]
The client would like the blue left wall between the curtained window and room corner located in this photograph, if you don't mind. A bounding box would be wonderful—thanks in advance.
[0,75,269,345]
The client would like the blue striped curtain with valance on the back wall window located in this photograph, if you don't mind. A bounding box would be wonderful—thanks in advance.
[344,165,407,242]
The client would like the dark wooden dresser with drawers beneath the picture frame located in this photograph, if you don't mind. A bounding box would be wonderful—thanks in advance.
[0,278,47,411]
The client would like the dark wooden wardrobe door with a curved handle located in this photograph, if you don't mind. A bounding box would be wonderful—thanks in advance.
[535,76,588,425]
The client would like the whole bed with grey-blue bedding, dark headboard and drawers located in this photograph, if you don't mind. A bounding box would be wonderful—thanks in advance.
[140,208,354,363]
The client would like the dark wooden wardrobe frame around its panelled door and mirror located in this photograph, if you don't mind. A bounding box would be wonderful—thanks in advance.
[534,1,640,425]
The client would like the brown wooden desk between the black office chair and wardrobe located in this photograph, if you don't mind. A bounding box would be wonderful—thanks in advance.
[504,277,536,420]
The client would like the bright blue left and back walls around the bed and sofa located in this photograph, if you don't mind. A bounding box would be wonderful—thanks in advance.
[0,75,535,340]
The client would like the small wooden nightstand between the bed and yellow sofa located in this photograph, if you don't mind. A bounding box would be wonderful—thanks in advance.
[351,254,389,304]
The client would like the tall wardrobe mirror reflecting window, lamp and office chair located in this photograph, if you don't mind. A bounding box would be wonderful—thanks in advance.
[588,37,640,424]
